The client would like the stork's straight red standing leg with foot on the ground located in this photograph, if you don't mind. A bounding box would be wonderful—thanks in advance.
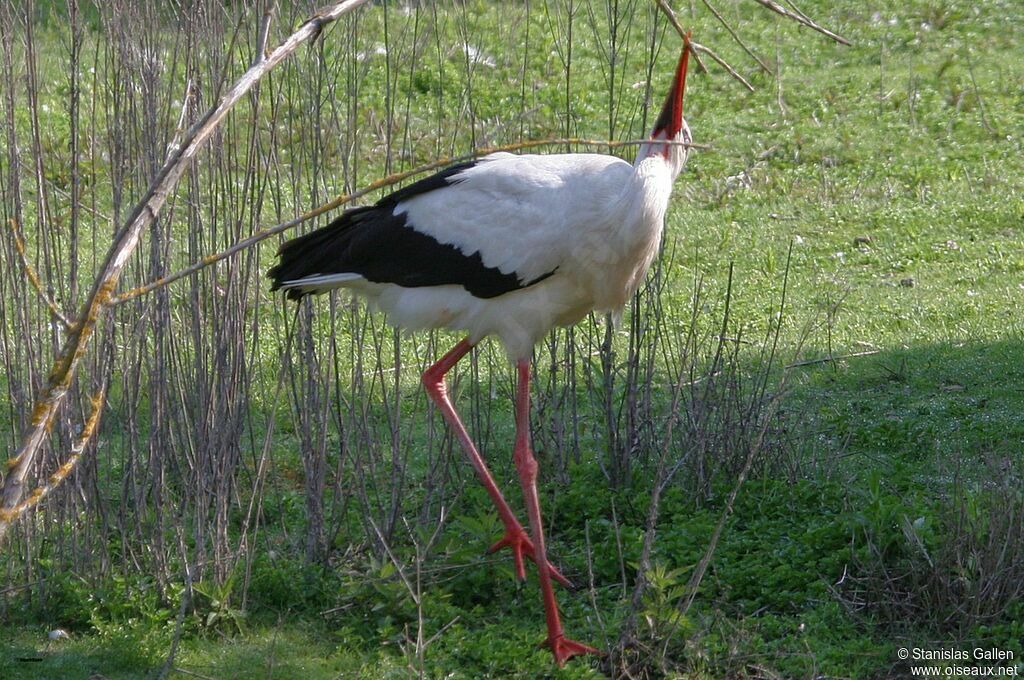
[515,359,601,667]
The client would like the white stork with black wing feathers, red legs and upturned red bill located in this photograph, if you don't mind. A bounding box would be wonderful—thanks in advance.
[267,41,690,666]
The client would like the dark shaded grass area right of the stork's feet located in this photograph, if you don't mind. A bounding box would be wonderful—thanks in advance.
[593,339,1024,677]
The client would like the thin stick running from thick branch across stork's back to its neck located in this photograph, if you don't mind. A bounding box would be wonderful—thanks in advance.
[110,138,712,305]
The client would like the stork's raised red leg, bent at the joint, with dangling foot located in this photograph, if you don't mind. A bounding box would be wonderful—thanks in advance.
[423,340,572,588]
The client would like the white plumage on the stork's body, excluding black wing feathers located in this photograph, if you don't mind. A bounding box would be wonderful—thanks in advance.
[282,148,681,360]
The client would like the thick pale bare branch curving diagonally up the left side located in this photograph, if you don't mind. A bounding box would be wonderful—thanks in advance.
[0,0,367,545]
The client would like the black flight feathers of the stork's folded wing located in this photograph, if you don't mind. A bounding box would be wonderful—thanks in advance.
[267,163,550,299]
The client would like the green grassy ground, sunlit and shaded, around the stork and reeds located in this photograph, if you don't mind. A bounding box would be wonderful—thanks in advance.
[0,0,1024,679]
